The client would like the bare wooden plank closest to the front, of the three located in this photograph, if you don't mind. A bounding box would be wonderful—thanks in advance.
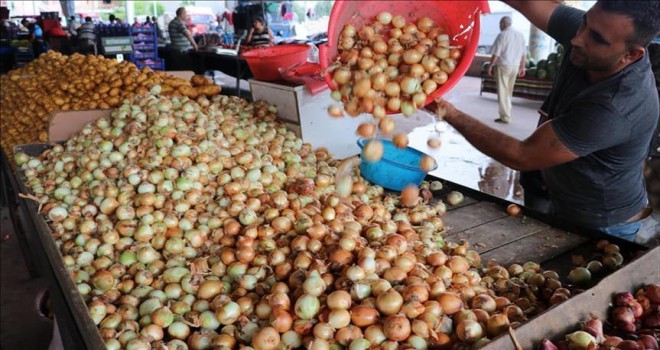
[481,228,589,266]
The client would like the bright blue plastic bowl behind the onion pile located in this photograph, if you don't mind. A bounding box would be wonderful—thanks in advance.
[358,139,438,191]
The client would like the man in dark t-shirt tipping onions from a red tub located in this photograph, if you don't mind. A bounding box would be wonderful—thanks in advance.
[437,0,660,240]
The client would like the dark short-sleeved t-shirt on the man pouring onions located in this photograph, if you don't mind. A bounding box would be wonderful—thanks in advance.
[541,6,660,228]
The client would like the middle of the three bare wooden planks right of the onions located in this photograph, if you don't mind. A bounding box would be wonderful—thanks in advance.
[445,216,550,253]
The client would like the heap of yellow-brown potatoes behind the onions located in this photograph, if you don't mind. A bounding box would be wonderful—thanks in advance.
[0,51,220,158]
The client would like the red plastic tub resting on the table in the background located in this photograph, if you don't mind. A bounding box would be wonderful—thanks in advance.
[242,44,311,81]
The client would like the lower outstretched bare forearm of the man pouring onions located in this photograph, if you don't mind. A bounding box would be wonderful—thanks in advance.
[444,110,524,170]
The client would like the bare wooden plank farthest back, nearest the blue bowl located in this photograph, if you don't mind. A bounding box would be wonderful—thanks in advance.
[442,202,507,236]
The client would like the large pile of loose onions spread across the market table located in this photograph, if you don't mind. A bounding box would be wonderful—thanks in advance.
[15,91,570,350]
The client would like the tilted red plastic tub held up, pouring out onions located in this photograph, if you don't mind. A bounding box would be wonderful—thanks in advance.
[319,0,490,112]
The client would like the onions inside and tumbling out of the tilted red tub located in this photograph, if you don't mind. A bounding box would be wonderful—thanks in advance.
[328,12,462,167]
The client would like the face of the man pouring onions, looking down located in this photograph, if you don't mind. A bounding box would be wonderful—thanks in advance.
[570,5,634,72]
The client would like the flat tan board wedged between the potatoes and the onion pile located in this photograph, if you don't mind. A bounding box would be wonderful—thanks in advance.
[48,109,112,142]
